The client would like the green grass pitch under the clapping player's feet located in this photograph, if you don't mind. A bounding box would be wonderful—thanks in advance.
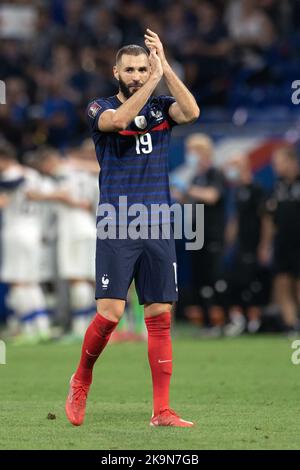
[0,336,300,450]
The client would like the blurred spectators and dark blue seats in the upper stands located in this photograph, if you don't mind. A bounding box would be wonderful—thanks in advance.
[0,0,300,152]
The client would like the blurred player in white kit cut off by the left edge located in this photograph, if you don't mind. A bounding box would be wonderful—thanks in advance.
[0,141,50,344]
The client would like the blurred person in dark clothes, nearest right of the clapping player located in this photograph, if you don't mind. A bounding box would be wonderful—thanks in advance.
[171,133,225,333]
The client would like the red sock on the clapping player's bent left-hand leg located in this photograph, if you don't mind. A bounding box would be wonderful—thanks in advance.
[74,313,118,384]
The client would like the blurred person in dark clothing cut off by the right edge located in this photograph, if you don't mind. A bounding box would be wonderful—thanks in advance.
[260,146,300,332]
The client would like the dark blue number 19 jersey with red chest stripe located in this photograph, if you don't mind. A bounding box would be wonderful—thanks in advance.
[87,96,176,225]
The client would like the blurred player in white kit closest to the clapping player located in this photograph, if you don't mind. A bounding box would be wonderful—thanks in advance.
[31,148,98,341]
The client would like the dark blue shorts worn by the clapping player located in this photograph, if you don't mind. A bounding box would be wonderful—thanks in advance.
[95,227,178,305]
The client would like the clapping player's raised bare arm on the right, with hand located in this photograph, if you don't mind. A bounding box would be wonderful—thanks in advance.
[145,29,200,124]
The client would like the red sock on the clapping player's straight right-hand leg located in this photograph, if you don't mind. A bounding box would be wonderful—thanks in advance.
[145,312,172,416]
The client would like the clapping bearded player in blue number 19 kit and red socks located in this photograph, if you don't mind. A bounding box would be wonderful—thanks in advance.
[66,29,199,427]
